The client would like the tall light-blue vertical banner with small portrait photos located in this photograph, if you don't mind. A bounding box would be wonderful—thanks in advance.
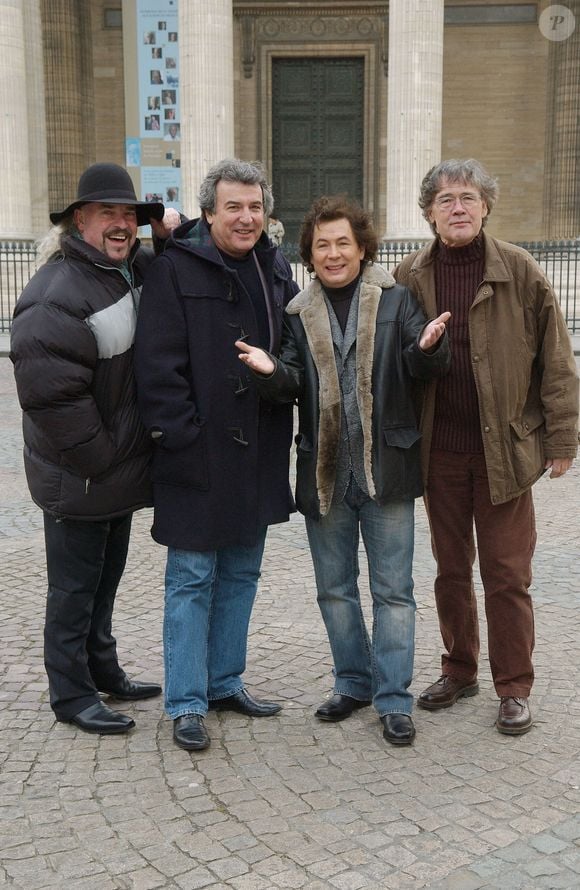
[124,0,181,217]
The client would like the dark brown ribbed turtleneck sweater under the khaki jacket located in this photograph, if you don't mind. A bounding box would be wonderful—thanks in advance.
[431,233,485,453]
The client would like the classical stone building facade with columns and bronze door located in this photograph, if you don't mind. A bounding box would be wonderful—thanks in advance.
[0,0,580,240]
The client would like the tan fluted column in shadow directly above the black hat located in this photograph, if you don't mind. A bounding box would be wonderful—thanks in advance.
[41,0,94,210]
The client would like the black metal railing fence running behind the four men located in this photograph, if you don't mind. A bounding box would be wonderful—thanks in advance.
[0,240,580,334]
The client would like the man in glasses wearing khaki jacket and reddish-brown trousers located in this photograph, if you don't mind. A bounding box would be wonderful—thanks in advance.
[394,160,578,735]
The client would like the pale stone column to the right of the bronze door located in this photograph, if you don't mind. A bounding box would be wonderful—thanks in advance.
[385,0,443,240]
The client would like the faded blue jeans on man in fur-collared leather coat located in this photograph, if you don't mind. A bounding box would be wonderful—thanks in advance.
[306,488,415,717]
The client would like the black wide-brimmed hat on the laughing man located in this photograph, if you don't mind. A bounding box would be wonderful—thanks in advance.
[50,164,165,226]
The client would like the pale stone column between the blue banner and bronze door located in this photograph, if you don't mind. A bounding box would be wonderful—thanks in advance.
[179,0,234,216]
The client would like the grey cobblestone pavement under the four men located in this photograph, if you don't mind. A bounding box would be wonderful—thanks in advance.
[0,358,580,890]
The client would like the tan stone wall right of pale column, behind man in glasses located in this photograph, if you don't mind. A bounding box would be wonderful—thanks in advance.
[441,18,549,241]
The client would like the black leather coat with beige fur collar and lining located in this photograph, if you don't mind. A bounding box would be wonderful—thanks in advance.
[254,266,450,518]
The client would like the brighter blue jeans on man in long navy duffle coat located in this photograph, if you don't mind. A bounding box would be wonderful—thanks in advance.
[163,528,266,720]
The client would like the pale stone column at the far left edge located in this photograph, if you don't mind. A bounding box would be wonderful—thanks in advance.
[0,0,48,239]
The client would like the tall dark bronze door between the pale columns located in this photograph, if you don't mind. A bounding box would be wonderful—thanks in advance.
[272,58,364,248]
